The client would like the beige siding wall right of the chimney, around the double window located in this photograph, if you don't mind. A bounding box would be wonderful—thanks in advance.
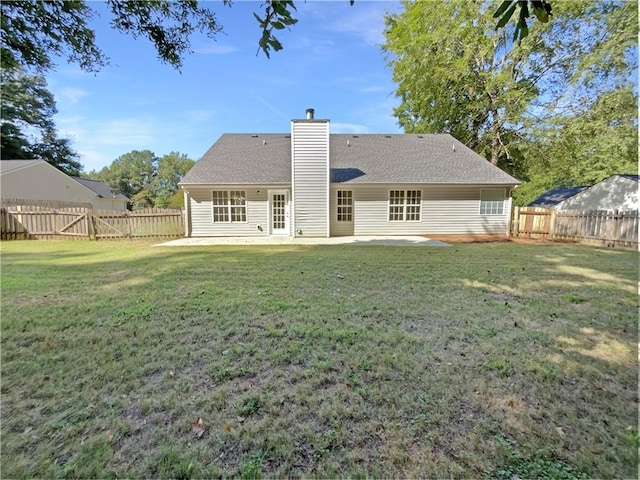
[344,184,510,235]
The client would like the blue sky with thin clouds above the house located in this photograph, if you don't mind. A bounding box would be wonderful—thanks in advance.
[46,0,401,173]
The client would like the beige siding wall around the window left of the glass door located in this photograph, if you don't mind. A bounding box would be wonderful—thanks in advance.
[188,185,269,237]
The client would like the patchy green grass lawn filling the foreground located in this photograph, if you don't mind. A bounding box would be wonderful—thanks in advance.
[0,241,638,479]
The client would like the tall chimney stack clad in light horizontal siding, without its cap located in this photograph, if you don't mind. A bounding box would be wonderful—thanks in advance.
[291,120,329,237]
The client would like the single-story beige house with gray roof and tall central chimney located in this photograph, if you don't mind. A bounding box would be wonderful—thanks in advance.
[180,109,520,237]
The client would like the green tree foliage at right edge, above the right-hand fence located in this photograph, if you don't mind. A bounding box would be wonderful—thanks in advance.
[514,2,638,205]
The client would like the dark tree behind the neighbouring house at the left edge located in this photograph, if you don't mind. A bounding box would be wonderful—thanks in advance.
[0,65,82,175]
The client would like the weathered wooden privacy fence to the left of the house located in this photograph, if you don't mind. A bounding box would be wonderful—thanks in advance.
[0,203,184,240]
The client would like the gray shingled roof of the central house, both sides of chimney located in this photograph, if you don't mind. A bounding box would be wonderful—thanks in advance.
[181,133,520,185]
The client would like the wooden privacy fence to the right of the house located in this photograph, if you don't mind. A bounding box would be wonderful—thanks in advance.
[511,207,639,248]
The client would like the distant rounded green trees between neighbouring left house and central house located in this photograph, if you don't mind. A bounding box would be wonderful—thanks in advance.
[88,150,195,208]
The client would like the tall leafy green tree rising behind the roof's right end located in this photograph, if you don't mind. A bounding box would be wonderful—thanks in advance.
[383,1,538,170]
